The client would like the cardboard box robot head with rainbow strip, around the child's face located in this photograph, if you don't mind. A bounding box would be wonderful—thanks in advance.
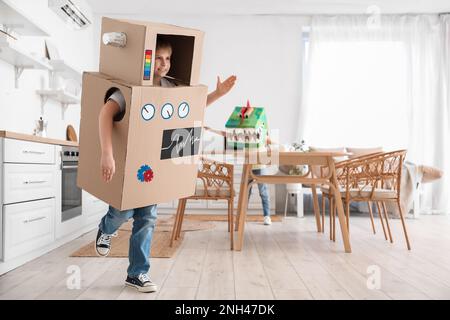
[99,17,204,86]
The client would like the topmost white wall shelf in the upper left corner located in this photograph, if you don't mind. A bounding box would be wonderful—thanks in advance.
[0,0,49,37]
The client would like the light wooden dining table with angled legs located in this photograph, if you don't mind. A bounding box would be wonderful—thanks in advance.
[203,148,351,253]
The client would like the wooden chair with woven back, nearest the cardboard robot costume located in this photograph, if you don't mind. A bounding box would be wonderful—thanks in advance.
[170,157,235,250]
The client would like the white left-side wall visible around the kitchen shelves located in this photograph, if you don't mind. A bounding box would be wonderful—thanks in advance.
[0,0,96,140]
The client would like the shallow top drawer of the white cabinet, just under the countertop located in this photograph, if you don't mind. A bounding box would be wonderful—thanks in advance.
[3,139,55,164]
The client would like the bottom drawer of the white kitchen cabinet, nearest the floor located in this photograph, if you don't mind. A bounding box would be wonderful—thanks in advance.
[3,198,55,261]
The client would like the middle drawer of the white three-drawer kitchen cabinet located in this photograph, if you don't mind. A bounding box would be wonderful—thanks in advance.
[3,163,57,204]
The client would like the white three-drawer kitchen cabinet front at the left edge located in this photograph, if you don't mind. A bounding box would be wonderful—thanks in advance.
[0,138,60,261]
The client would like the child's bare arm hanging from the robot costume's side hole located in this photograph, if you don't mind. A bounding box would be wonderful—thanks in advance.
[98,100,120,182]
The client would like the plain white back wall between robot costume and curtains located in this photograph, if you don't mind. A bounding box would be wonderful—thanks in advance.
[94,15,309,143]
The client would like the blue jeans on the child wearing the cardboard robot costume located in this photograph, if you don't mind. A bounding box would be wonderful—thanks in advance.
[98,204,157,277]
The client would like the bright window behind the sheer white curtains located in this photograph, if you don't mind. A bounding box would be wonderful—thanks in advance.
[303,34,408,150]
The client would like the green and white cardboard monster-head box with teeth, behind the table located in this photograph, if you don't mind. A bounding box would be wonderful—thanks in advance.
[225,101,267,149]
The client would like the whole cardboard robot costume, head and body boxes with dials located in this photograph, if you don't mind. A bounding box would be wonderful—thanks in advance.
[78,18,207,210]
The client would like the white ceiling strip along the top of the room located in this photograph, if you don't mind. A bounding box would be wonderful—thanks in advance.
[85,0,450,15]
